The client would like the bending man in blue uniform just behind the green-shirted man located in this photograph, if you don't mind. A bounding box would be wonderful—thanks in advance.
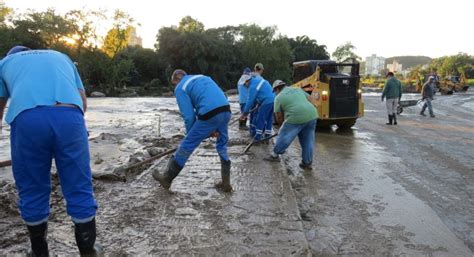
[240,73,275,141]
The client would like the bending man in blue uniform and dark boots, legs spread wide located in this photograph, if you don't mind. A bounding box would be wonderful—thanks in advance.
[153,70,232,192]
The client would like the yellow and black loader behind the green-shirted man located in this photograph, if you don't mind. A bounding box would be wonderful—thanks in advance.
[293,60,364,129]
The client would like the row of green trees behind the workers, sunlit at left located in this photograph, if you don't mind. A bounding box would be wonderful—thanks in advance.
[0,2,329,96]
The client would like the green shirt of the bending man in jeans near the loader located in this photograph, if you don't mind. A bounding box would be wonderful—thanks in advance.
[274,87,318,124]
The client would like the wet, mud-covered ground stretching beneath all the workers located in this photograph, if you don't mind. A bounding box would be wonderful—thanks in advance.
[0,92,474,256]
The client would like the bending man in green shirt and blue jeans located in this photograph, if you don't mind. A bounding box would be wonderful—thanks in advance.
[264,80,318,170]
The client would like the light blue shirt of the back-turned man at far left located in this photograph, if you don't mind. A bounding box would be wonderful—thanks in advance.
[0,50,84,123]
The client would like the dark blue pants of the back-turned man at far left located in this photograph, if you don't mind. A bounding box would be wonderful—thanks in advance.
[10,106,97,226]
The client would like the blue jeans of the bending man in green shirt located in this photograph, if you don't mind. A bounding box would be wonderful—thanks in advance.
[273,120,317,165]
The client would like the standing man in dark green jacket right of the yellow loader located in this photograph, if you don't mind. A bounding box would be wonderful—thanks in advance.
[382,72,402,125]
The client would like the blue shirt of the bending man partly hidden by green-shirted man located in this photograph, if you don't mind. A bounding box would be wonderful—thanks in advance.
[244,77,275,113]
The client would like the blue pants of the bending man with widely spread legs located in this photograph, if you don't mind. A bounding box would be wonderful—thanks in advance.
[174,112,231,167]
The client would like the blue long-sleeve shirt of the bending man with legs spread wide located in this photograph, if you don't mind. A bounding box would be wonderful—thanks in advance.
[174,75,229,132]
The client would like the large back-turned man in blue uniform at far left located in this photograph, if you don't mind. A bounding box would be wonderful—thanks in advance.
[0,46,101,256]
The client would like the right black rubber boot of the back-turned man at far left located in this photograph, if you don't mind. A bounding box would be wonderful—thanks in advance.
[74,218,104,256]
